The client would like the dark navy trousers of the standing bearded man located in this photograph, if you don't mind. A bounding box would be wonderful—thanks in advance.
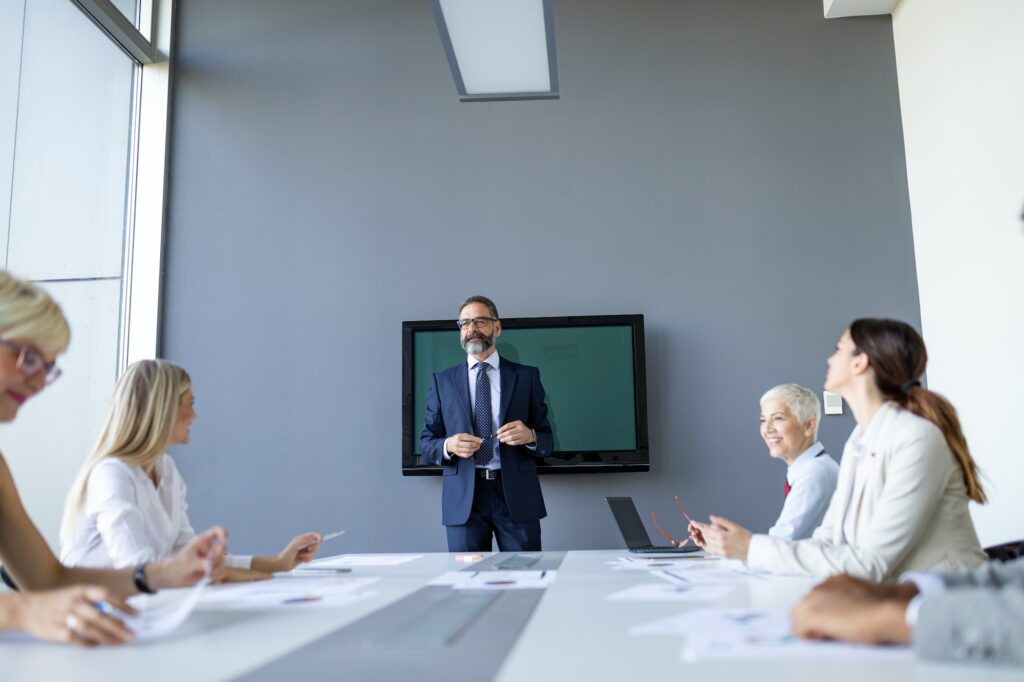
[444,478,541,552]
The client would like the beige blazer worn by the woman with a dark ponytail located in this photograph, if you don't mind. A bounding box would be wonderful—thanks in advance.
[746,401,987,581]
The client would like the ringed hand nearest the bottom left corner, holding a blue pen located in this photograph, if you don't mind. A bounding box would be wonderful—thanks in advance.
[11,585,136,646]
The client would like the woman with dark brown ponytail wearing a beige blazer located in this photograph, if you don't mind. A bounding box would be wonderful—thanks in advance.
[691,318,986,581]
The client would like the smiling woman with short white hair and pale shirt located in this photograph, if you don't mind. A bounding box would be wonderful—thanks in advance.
[761,384,839,540]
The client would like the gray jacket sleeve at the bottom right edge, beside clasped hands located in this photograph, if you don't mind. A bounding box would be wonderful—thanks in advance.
[913,586,1024,666]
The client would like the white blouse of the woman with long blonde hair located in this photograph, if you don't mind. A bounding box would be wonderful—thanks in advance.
[60,455,252,568]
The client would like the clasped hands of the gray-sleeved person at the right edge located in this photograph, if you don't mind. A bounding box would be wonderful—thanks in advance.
[792,589,910,644]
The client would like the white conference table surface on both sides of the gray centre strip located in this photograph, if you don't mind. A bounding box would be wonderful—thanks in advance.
[0,550,1021,682]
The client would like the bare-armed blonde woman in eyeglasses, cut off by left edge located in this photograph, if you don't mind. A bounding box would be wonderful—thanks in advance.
[0,272,227,645]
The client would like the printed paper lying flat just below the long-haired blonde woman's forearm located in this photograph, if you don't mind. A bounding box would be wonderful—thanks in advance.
[201,577,381,608]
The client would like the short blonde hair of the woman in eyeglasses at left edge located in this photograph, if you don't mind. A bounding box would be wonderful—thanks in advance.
[0,270,71,354]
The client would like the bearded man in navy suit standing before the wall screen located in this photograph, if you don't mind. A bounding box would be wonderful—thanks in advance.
[420,296,554,552]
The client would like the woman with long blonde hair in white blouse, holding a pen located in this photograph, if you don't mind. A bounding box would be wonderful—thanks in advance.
[60,359,322,582]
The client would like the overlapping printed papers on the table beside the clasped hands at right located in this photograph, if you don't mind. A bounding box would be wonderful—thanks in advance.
[630,608,911,660]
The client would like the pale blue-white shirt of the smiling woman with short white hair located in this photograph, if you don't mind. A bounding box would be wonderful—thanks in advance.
[768,442,839,540]
